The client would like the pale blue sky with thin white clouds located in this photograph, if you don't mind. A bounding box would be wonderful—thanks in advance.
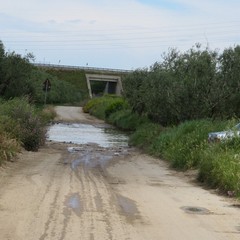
[0,0,240,70]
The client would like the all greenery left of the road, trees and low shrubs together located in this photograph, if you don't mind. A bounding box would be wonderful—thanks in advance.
[0,41,66,165]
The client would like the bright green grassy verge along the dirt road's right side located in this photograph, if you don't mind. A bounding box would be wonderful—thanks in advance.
[84,96,240,197]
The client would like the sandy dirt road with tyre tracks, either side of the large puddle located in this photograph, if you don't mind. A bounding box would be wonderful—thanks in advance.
[0,107,240,240]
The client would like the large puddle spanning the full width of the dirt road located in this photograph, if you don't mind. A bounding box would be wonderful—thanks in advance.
[47,123,128,148]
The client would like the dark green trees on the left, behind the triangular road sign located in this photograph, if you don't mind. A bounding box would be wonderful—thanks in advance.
[0,41,82,104]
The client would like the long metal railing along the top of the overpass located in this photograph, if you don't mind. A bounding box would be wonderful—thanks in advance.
[33,63,133,73]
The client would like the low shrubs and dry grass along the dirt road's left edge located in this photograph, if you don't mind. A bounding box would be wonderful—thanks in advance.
[0,97,54,165]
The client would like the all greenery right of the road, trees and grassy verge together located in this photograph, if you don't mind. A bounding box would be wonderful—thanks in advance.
[85,45,240,197]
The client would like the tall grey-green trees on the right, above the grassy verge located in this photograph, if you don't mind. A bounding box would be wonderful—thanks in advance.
[123,44,240,126]
